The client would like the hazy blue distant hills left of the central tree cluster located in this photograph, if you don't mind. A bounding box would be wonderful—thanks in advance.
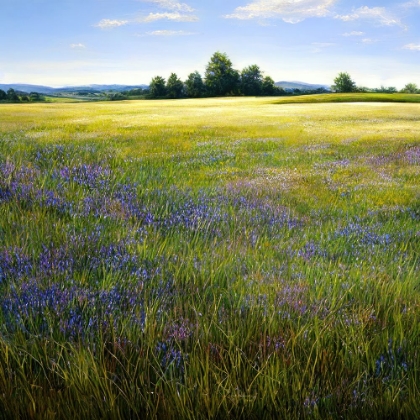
[0,83,148,95]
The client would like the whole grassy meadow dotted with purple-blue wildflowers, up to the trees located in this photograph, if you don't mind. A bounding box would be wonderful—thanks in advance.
[0,95,420,419]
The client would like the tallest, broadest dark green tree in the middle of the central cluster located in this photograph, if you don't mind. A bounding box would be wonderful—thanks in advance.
[205,52,240,96]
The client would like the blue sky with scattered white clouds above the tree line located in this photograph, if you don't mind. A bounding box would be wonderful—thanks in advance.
[0,0,420,89]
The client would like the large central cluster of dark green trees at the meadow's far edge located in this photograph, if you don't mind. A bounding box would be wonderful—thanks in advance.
[149,52,285,99]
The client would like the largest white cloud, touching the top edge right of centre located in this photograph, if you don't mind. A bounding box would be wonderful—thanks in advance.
[224,0,336,23]
